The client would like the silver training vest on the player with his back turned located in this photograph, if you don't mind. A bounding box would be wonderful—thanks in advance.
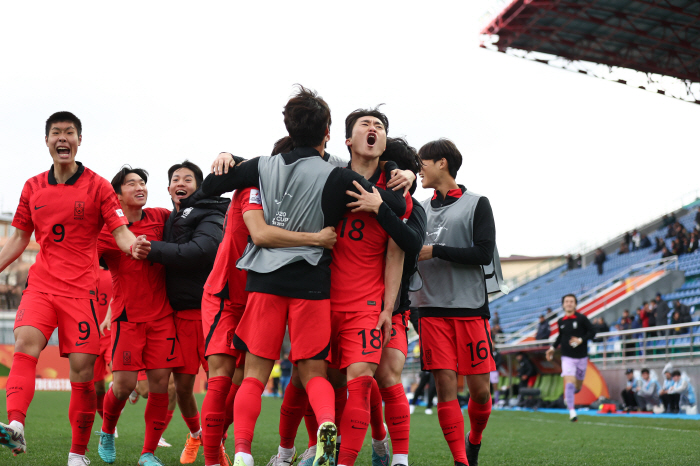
[236,155,334,273]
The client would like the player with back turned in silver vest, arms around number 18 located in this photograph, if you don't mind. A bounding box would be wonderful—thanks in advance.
[202,86,406,466]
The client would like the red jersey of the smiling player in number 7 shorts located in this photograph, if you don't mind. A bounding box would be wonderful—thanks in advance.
[97,207,173,322]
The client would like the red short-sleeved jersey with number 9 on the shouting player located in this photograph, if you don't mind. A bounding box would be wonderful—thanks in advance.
[12,162,128,299]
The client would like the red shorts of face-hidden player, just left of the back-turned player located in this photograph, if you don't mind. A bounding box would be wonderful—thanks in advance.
[202,291,245,367]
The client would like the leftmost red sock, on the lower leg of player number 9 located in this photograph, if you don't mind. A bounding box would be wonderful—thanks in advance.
[6,353,38,424]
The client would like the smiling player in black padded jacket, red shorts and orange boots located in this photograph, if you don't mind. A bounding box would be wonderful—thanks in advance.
[147,160,230,460]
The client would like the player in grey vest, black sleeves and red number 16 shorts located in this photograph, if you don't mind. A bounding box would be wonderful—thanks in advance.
[412,139,500,466]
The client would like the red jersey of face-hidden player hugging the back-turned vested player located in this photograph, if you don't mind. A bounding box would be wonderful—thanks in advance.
[204,188,263,306]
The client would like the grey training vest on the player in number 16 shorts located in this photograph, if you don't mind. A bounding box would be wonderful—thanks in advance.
[411,191,505,309]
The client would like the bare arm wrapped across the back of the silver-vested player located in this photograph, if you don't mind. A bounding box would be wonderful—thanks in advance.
[243,210,337,249]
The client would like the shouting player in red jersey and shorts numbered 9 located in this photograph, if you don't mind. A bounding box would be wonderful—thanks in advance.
[0,112,148,465]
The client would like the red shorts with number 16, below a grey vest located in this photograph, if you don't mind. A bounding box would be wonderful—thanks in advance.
[418,317,496,375]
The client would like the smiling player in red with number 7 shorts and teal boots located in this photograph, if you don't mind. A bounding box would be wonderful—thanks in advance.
[97,165,183,466]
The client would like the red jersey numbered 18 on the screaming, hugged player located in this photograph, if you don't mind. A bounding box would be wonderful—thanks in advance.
[331,171,413,312]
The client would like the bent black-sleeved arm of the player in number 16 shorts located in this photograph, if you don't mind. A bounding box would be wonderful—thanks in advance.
[419,197,496,265]
